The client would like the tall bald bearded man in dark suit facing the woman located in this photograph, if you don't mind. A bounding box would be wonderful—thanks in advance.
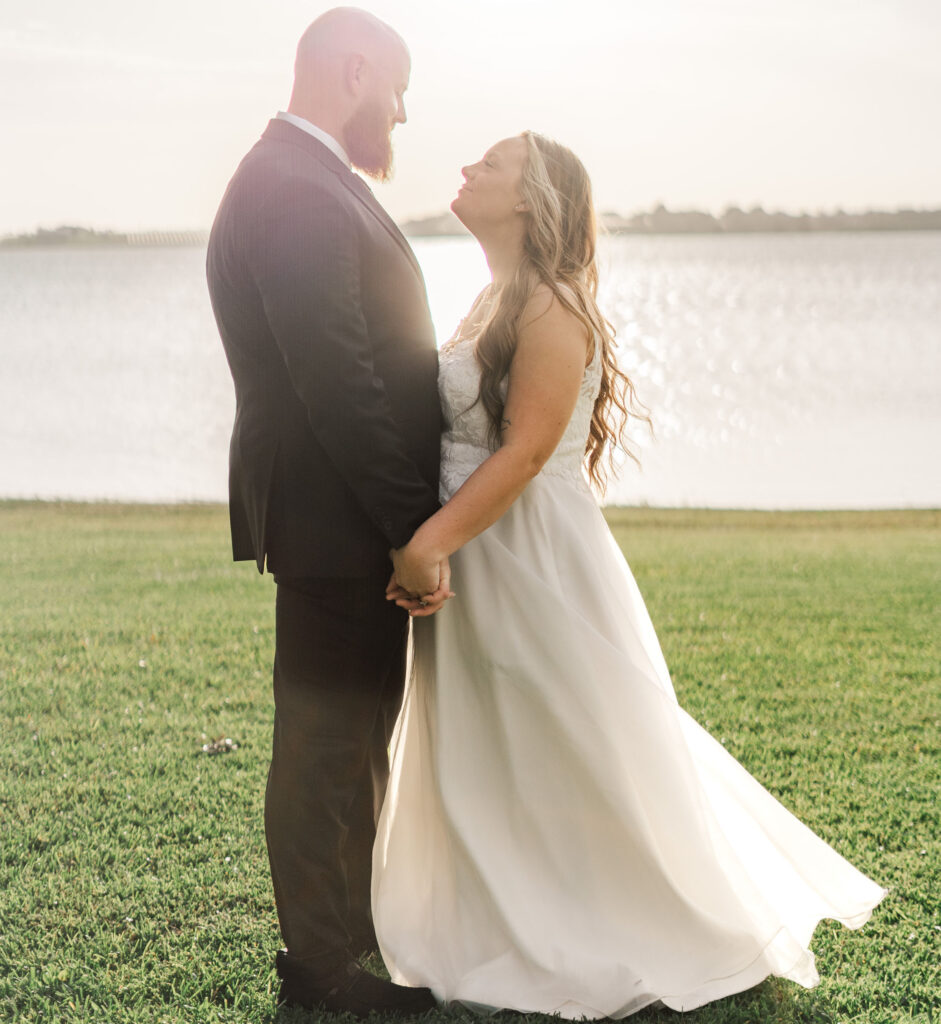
[207,7,448,1016]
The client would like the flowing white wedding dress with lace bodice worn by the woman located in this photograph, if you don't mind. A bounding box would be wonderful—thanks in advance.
[373,323,885,1018]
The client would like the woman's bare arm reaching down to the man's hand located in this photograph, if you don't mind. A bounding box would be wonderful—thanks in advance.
[390,286,589,602]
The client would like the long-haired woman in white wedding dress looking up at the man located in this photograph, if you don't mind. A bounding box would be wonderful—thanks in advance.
[373,132,885,1018]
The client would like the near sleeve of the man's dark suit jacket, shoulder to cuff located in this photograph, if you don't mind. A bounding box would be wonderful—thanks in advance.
[249,182,438,548]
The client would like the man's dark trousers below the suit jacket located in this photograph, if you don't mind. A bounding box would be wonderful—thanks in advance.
[265,575,409,968]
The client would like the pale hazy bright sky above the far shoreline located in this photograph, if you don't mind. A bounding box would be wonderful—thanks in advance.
[0,0,941,234]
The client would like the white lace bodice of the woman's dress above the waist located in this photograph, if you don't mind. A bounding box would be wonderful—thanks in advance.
[438,338,601,501]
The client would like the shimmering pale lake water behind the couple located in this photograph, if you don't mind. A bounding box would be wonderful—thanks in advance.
[0,231,941,508]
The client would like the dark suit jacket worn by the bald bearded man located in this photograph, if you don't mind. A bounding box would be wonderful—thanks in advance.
[207,120,441,577]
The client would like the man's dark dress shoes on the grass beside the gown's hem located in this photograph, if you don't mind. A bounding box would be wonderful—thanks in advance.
[274,949,437,1017]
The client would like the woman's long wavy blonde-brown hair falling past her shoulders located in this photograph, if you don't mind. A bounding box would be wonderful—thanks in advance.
[475,131,650,494]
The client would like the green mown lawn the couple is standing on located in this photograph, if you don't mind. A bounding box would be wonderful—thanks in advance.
[0,502,941,1024]
